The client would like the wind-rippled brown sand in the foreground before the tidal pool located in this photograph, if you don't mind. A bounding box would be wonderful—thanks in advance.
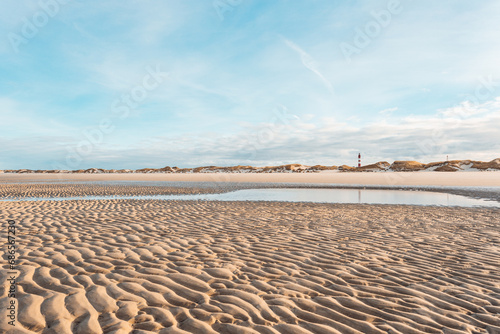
[0,181,500,334]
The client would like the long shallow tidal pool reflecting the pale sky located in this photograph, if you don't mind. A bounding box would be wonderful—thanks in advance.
[0,188,500,207]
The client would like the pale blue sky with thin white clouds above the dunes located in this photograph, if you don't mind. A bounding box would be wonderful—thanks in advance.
[0,0,500,170]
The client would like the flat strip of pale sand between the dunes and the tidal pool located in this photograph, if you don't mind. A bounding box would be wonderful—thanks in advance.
[0,172,500,202]
